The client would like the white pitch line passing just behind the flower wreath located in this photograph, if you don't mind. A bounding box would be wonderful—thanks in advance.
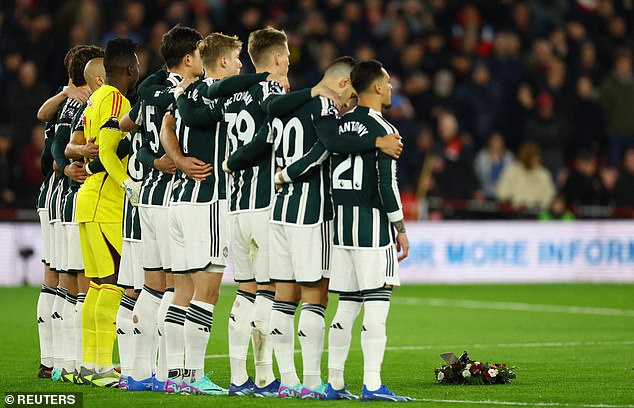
[205,341,634,359]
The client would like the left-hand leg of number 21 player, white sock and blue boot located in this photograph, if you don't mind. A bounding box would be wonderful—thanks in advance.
[326,247,363,399]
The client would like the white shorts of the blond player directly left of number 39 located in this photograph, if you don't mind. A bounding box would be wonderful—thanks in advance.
[169,200,229,273]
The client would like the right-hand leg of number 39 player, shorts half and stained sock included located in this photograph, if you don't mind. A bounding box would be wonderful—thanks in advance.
[245,211,276,388]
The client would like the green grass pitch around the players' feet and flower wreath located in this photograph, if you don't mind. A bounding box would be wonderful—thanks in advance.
[0,284,634,407]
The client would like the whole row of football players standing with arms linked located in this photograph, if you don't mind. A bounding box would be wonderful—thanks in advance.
[37,25,409,401]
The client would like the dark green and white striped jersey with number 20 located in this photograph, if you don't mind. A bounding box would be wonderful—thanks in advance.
[271,94,337,225]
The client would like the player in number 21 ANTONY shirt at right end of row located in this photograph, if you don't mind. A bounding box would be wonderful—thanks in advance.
[317,60,410,401]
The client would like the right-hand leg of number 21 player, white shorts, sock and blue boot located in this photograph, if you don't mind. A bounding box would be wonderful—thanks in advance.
[353,245,410,401]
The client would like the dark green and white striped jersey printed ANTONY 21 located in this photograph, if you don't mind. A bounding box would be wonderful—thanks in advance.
[331,106,403,248]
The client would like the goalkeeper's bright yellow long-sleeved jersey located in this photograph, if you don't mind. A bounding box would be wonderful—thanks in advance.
[76,85,130,222]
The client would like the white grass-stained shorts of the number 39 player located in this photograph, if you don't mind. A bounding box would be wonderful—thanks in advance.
[229,210,271,285]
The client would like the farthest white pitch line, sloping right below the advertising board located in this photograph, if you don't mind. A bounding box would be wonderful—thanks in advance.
[392,296,634,317]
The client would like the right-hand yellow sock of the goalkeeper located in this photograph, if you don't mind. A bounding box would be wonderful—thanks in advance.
[94,283,123,368]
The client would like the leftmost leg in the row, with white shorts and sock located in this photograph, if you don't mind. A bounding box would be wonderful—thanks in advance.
[37,208,59,378]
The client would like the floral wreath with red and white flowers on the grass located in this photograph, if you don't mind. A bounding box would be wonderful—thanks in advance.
[434,351,517,385]
